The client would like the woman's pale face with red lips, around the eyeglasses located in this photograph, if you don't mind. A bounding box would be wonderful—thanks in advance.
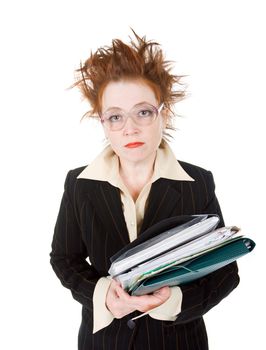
[102,80,165,167]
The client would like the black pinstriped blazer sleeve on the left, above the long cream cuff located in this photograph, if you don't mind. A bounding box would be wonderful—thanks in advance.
[50,170,100,312]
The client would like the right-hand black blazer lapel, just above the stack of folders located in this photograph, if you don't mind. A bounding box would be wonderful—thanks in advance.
[140,178,181,234]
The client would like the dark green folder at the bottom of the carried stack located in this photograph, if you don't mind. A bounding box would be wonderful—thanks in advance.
[131,237,255,295]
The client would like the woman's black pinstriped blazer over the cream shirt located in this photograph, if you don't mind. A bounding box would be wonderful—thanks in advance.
[50,162,239,350]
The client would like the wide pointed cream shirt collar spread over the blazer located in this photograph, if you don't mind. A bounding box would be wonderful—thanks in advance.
[77,140,194,187]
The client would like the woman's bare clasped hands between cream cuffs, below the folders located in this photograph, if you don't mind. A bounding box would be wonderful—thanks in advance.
[106,280,171,318]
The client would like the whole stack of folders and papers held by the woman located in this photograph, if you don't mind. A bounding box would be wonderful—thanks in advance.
[109,214,255,295]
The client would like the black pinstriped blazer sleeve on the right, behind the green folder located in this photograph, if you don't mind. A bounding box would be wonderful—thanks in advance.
[171,172,239,324]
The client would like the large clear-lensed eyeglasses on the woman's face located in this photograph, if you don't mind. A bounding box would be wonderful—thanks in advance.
[100,102,163,131]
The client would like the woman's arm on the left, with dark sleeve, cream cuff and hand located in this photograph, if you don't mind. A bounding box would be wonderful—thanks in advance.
[50,171,177,333]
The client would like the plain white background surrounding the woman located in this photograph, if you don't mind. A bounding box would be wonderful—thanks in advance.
[0,0,266,350]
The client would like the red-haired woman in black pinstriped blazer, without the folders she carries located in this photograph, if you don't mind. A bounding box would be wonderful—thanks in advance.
[51,33,239,350]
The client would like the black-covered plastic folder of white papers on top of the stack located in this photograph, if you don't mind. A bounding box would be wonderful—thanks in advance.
[109,214,220,276]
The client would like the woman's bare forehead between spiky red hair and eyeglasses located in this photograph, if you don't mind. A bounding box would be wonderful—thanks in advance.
[102,80,157,111]
